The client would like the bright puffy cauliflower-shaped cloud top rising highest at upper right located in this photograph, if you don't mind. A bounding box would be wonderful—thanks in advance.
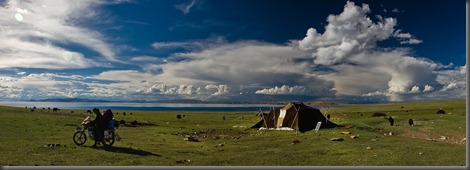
[297,1,397,65]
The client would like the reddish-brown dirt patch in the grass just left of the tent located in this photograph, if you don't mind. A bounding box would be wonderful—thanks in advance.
[173,129,248,139]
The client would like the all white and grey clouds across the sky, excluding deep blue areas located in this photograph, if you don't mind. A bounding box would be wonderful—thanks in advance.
[0,0,467,102]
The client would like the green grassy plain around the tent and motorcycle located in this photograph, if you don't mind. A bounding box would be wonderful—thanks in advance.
[0,100,467,166]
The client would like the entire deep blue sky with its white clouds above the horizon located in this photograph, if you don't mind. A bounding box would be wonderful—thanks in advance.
[0,0,467,103]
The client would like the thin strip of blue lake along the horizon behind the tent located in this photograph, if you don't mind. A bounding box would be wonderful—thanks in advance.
[0,101,340,112]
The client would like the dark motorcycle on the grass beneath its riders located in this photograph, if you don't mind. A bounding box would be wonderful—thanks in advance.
[73,117,121,146]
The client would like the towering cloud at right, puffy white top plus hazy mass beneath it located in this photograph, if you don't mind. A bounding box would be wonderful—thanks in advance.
[293,1,440,100]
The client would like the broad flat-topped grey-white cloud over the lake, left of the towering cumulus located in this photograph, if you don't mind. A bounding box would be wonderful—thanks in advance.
[150,41,332,99]
